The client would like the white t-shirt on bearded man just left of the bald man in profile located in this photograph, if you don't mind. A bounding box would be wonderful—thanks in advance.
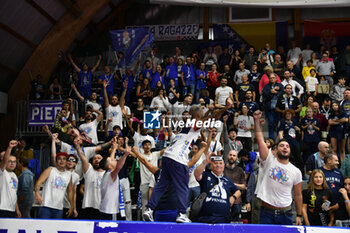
[82,164,105,210]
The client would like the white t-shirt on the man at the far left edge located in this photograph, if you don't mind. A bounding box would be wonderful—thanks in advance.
[0,169,18,212]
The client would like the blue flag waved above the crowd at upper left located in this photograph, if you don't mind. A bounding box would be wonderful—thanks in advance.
[109,28,154,66]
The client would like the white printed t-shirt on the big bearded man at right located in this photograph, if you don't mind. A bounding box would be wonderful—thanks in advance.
[257,152,302,208]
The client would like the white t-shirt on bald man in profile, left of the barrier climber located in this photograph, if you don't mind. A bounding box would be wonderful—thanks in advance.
[100,171,119,214]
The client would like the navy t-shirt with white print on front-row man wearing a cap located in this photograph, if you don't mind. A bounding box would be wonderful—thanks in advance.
[198,172,238,223]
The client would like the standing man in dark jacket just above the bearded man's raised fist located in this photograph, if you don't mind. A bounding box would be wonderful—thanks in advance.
[260,73,283,139]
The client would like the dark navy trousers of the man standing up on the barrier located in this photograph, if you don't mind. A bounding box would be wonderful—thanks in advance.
[147,157,189,213]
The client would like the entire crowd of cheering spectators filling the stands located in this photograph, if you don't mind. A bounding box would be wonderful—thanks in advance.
[0,41,350,226]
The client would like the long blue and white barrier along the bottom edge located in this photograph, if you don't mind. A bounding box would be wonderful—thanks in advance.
[0,219,350,233]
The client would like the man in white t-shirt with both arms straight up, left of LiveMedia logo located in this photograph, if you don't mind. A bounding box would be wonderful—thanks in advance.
[103,79,128,131]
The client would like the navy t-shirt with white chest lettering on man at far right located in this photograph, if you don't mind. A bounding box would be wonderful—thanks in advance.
[321,167,344,204]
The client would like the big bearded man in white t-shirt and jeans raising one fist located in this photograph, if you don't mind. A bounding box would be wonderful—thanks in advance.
[254,111,302,225]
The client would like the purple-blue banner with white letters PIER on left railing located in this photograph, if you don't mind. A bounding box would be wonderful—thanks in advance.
[28,100,62,126]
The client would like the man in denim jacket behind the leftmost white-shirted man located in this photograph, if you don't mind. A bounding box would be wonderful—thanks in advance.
[17,157,34,218]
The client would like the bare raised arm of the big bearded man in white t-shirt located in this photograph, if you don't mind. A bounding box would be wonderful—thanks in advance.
[253,110,269,160]
